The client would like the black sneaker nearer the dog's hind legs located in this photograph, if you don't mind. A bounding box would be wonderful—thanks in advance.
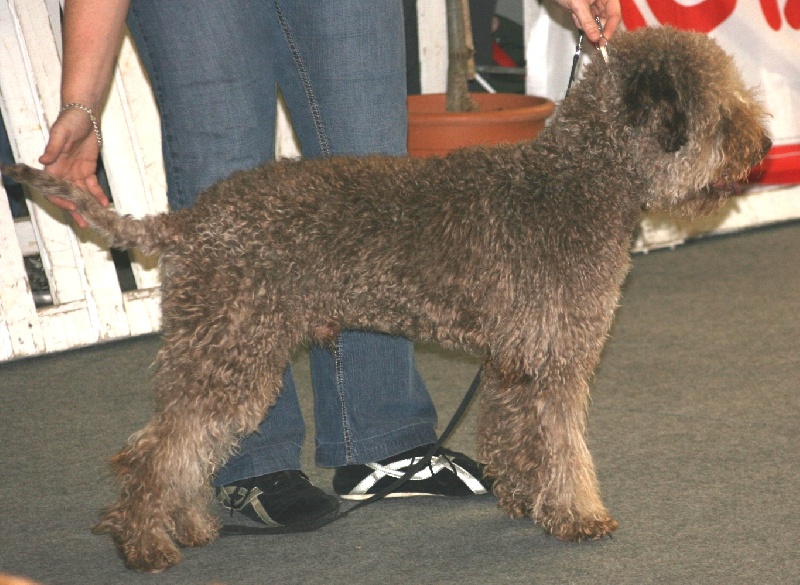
[217,470,339,534]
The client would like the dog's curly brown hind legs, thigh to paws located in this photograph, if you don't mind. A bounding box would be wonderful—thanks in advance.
[95,294,291,572]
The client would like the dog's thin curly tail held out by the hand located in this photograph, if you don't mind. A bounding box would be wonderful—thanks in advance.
[0,164,167,254]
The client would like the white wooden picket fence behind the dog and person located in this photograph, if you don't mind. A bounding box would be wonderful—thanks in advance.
[0,0,800,361]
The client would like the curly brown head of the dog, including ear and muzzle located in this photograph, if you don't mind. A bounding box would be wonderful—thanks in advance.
[576,27,771,215]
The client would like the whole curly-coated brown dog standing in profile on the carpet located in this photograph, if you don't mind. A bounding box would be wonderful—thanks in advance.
[5,28,770,571]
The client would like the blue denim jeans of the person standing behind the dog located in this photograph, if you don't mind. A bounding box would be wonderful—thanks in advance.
[128,0,436,485]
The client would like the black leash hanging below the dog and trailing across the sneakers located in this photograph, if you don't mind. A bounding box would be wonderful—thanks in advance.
[220,366,483,536]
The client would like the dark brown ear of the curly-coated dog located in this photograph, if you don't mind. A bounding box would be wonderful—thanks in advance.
[623,63,689,152]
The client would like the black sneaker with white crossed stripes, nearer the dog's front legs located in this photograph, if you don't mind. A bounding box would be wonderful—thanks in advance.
[333,445,492,500]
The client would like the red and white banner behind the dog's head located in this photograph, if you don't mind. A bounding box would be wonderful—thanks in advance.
[621,0,800,184]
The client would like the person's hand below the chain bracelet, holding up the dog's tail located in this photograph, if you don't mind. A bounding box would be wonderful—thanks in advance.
[39,109,108,228]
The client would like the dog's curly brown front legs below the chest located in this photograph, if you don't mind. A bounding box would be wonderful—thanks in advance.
[478,364,617,541]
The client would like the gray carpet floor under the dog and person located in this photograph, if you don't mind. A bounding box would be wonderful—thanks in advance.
[0,224,800,585]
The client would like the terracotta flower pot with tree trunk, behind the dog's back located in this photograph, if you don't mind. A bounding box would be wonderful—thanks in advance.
[408,93,555,156]
